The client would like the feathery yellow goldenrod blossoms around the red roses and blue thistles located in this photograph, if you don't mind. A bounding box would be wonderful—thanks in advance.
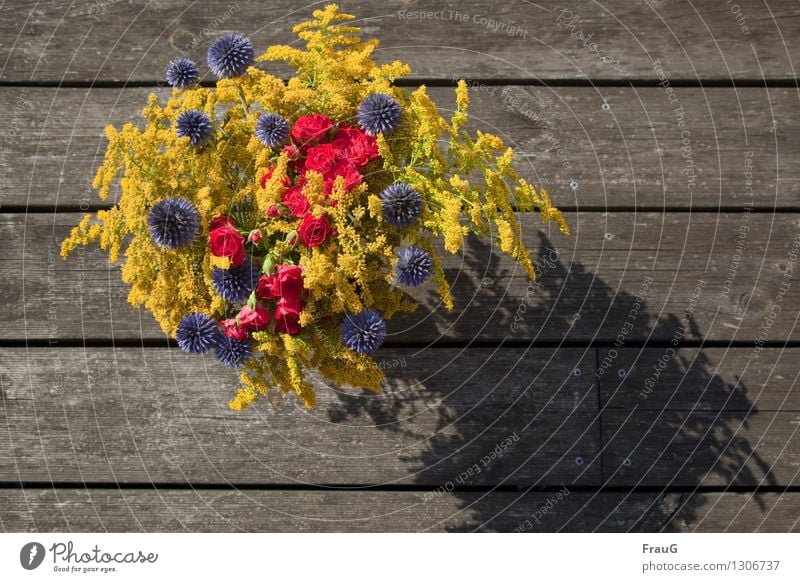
[62,5,569,410]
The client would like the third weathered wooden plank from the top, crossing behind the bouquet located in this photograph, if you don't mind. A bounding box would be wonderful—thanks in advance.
[0,212,800,344]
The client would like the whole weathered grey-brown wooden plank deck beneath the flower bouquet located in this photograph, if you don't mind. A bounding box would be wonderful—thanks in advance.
[0,0,800,532]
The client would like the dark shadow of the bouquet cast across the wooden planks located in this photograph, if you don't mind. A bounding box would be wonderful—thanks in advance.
[322,230,776,531]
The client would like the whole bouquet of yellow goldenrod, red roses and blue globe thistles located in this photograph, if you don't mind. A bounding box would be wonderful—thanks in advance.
[62,5,568,410]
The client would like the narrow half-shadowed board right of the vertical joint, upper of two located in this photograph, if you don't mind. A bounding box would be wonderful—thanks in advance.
[598,346,800,415]
